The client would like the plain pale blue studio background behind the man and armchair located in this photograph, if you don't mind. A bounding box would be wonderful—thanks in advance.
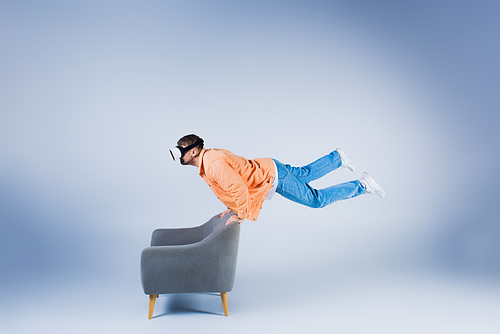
[0,0,500,333]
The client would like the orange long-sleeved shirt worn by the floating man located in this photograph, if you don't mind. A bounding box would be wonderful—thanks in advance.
[200,149,274,221]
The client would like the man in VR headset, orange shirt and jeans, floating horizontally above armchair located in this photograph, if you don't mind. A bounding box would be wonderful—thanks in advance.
[170,134,385,225]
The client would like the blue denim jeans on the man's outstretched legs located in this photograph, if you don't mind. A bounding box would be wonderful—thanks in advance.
[273,151,365,208]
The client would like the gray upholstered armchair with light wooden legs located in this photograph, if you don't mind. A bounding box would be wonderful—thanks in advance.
[141,213,240,319]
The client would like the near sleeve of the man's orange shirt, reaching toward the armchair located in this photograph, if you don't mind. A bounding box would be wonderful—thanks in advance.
[209,160,250,218]
